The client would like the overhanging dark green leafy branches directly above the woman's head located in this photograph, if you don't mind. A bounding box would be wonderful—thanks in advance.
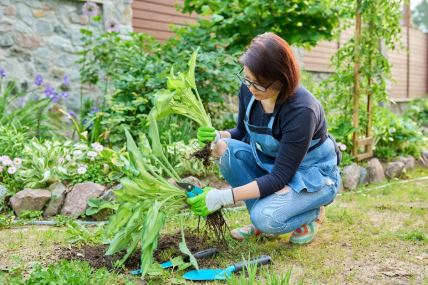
[182,0,345,50]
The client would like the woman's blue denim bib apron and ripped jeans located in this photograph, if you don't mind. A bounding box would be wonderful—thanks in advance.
[219,97,340,234]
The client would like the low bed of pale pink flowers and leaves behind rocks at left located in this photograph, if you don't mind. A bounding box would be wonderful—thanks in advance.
[0,139,127,192]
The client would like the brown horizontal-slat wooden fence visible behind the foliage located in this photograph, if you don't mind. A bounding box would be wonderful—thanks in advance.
[132,0,428,101]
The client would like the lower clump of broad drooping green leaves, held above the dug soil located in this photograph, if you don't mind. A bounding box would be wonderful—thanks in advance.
[106,129,186,276]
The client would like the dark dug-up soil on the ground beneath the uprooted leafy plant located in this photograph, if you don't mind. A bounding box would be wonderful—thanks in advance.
[57,229,217,272]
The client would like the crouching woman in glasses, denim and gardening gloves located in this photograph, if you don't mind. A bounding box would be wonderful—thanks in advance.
[188,33,340,244]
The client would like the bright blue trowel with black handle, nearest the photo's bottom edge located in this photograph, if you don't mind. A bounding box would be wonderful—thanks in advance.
[183,255,272,281]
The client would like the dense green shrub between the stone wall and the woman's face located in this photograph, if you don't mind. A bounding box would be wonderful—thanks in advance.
[80,26,238,144]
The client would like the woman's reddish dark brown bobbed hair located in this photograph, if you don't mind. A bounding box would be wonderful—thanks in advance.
[239,33,300,104]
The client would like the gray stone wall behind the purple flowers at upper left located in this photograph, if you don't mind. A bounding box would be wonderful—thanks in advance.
[0,0,132,109]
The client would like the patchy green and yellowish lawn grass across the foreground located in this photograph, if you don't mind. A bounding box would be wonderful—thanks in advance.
[0,165,428,284]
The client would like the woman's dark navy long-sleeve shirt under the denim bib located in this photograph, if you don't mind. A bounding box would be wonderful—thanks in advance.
[228,84,327,197]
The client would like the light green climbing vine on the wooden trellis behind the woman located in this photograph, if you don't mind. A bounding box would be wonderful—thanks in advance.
[315,0,404,160]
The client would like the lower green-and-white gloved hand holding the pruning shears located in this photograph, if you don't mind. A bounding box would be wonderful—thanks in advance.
[187,187,235,217]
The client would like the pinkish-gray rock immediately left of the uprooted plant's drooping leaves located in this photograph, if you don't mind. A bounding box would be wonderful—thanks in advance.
[61,182,105,218]
